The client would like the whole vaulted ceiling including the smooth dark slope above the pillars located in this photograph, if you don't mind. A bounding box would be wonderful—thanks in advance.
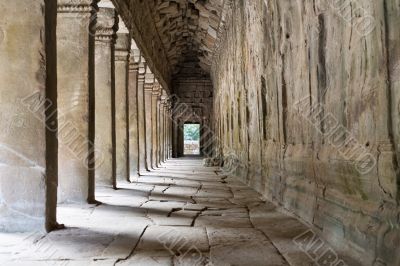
[112,0,228,88]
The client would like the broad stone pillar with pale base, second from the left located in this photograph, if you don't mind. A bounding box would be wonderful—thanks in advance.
[57,0,97,203]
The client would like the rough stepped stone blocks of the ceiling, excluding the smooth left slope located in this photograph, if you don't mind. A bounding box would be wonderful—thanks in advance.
[148,0,224,75]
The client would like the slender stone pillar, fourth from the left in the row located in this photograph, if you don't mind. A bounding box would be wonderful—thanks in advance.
[115,33,131,182]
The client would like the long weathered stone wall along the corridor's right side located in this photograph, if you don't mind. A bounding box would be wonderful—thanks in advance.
[212,0,400,265]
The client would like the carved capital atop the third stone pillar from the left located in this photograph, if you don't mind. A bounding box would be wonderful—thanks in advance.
[95,7,118,42]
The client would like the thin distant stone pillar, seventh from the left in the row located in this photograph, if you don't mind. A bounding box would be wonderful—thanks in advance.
[144,68,154,170]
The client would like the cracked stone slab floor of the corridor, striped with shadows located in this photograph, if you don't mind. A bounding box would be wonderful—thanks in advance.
[0,158,353,266]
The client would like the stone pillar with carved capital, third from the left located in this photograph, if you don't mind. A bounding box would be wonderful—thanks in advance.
[95,7,118,188]
